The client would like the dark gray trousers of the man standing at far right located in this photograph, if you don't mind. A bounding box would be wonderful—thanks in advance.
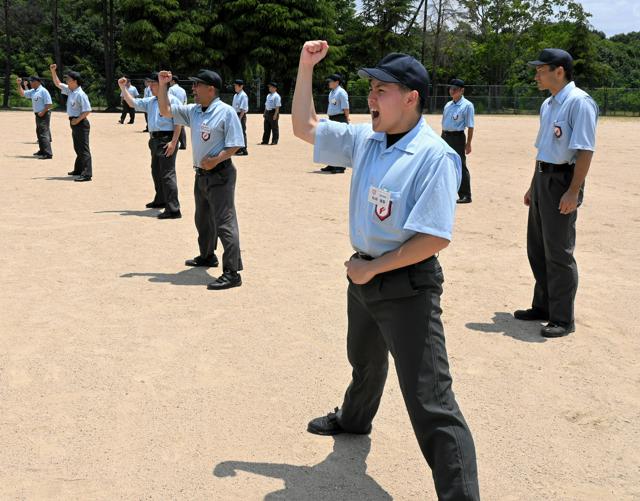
[527,171,583,325]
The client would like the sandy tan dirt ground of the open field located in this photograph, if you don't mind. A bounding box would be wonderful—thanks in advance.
[0,112,640,501]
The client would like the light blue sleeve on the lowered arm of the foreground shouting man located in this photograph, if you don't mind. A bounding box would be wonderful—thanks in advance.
[404,151,462,240]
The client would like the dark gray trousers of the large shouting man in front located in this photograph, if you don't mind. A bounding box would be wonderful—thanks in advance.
[338,257,480,501]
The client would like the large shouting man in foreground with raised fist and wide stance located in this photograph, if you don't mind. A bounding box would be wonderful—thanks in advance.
[291,41,480,501]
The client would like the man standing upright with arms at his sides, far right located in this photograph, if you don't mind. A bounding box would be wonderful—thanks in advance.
[514,48,598,338]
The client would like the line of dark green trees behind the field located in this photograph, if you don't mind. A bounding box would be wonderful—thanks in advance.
[0,0,640,108]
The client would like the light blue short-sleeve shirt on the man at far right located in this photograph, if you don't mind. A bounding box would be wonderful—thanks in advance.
[535,82,598,164]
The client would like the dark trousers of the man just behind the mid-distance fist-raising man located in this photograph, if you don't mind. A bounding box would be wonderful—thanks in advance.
[149,133,180,212]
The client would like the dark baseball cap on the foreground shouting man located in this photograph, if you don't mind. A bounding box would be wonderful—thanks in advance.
[358,52,429,101]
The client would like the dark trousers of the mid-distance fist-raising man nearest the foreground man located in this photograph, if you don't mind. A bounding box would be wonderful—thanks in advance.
[193,160,242,272]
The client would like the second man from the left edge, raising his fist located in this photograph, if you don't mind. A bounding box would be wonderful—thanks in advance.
[49,64,93,182]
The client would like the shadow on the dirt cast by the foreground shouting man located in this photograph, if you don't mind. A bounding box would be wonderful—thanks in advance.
[213,435,393,501]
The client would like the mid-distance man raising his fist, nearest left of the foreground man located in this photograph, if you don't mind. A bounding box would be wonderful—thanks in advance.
[158,70,244,290]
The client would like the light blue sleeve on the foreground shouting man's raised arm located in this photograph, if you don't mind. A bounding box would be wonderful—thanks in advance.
[313,118,362,167]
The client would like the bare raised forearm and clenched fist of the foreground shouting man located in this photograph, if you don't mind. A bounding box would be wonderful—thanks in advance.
[291,40,329,144]
